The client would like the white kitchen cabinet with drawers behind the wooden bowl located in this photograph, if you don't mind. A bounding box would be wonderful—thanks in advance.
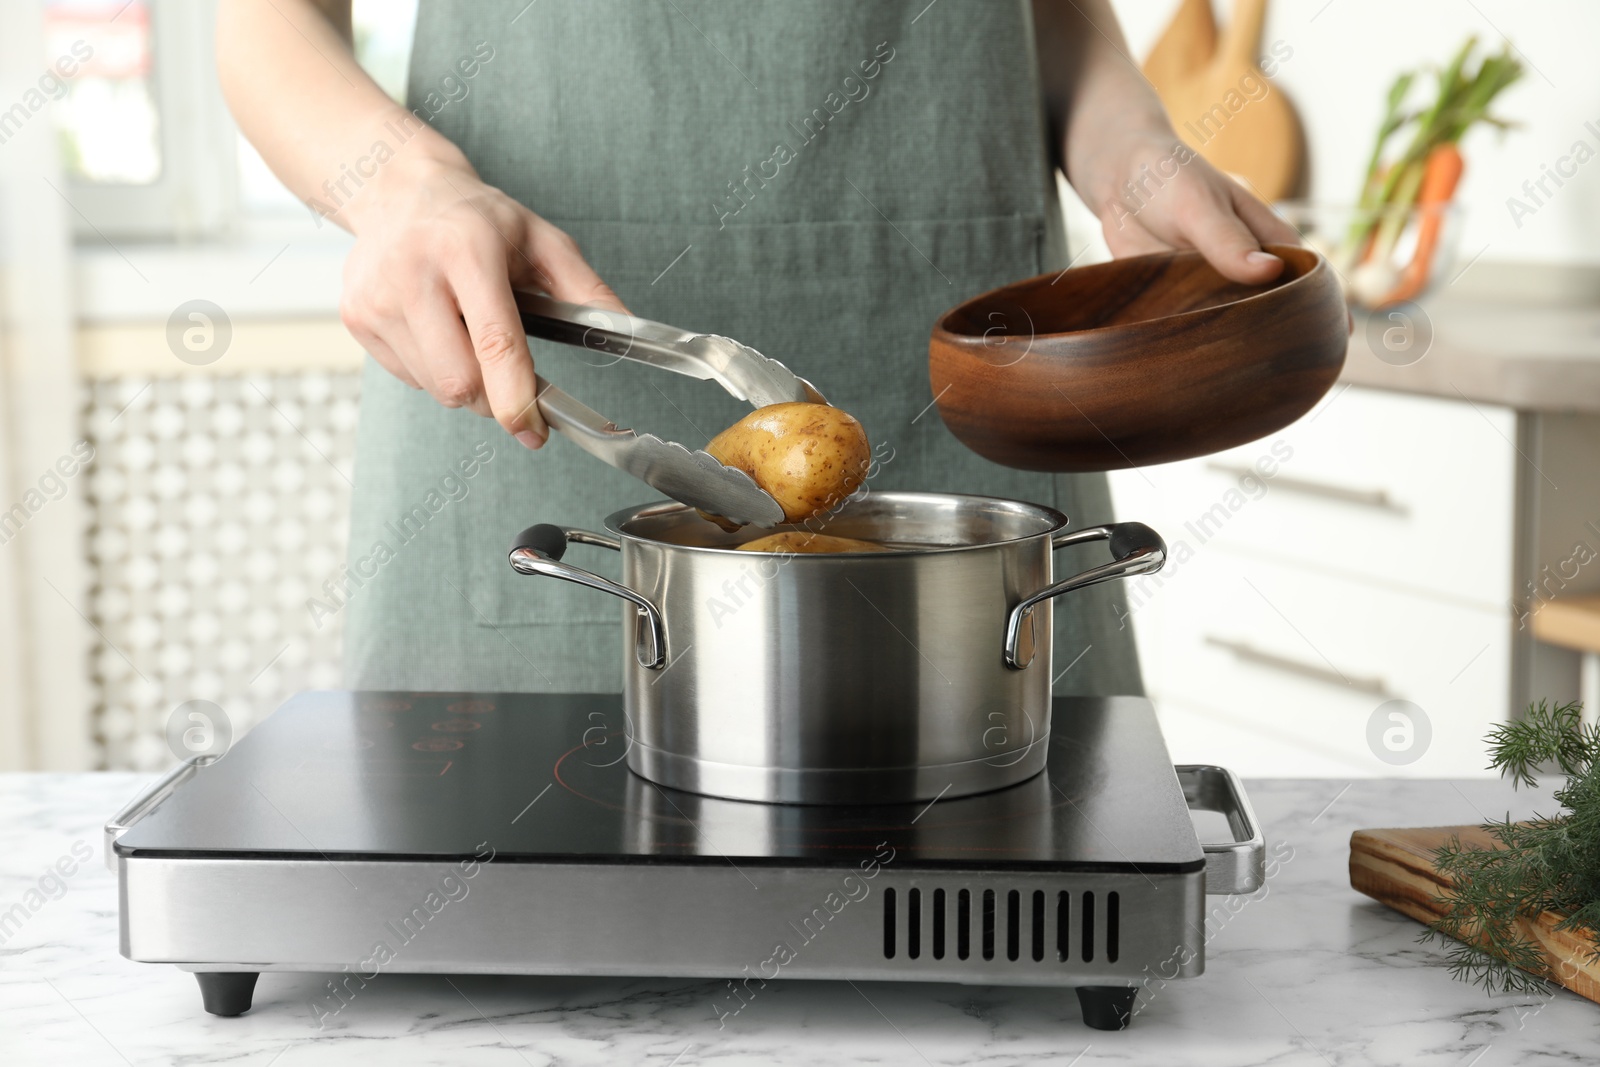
[1112,382,1600,776]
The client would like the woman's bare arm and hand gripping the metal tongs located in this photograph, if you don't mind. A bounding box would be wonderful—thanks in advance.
[216,0,622,448]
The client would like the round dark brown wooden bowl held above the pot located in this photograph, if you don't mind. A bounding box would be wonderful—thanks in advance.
[928,245,1349,470]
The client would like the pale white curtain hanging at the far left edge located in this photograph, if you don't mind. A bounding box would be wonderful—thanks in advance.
[0,0,96,771]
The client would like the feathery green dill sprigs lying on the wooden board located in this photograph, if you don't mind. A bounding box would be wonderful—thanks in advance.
[1421,701,1600,993]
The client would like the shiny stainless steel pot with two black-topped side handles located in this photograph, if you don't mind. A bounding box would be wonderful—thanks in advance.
[510,493,1166,803]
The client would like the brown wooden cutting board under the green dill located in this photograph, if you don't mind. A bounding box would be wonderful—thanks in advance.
[1350,825,1600,1003]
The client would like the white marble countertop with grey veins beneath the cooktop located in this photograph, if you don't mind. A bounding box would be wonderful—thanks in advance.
[0,774,1600,1067]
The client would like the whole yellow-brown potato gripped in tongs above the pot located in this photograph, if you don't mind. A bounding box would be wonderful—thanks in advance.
[706,403,872,523]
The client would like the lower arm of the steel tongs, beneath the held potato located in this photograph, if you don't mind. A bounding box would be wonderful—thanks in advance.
[539,379,784,528]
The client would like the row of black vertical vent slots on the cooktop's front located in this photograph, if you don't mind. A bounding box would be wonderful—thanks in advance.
[883,886,1122,963]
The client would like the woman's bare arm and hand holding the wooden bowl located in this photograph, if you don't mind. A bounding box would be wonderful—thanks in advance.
[1034,0,1299,282]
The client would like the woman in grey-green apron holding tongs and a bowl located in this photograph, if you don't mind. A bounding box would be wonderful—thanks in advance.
[218,0,1294,693]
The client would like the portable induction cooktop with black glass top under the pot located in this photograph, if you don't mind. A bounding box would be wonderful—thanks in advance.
[107,691,1262,1027]
